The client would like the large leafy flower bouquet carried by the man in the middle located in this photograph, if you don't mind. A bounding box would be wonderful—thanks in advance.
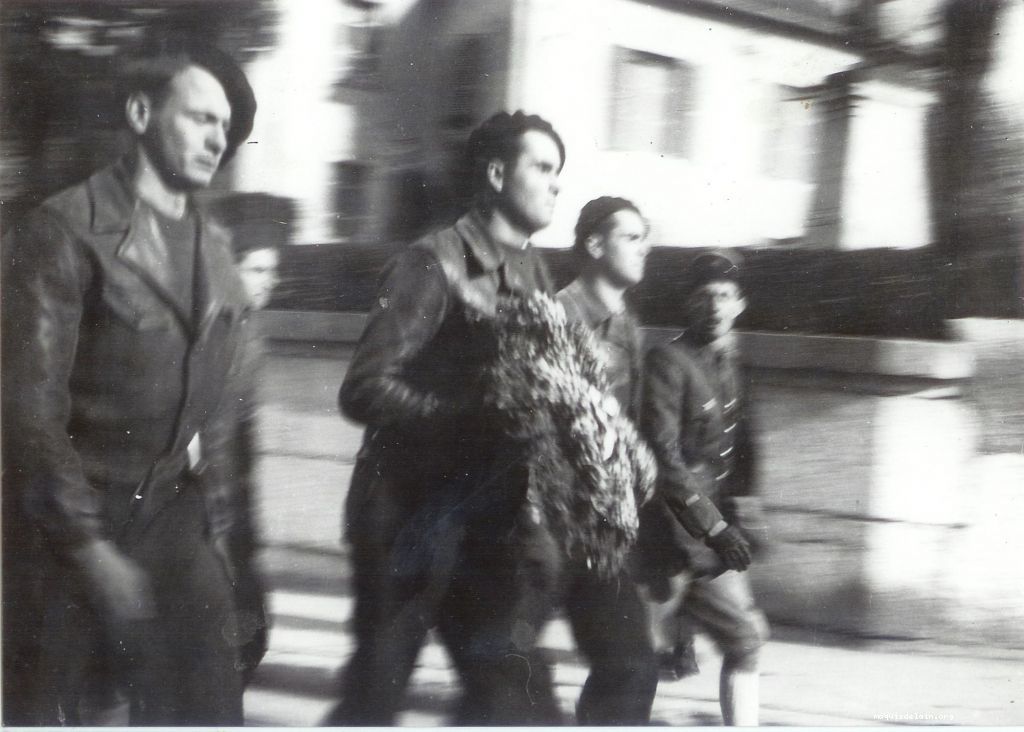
[483,293,655,576]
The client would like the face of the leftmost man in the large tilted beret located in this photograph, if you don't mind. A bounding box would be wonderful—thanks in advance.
[142,66,231,190]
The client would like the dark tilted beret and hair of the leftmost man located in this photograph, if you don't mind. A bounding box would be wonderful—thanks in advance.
[117,34,256,165]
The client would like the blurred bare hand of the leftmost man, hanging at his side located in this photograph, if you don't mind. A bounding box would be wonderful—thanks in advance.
[72,540,156,625]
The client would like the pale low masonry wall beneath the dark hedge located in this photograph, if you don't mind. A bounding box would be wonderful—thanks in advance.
[253,311,1024,647]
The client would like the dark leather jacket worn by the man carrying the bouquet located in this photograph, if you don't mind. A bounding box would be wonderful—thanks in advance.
[339,208,551,480]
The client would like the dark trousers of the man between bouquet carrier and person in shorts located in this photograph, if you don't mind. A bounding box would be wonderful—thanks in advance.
[564,565,657,726]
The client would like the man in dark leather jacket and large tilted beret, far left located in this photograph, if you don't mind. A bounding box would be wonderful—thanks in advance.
[2,39,256,726]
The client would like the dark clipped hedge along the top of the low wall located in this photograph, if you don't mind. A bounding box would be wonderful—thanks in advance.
[272,244,946,339]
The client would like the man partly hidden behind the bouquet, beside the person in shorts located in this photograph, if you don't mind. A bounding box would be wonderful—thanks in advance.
[557,196,657,725]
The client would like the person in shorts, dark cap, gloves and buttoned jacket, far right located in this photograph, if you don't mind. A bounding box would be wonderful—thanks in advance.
[635,252,768,726]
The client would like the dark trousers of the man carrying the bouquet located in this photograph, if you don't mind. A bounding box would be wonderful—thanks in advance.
[328,460,561,726]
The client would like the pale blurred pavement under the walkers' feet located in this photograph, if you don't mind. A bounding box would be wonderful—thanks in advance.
[246,547,1024,727]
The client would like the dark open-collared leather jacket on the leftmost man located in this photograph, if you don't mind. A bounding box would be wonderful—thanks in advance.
[3,162,245,547]
